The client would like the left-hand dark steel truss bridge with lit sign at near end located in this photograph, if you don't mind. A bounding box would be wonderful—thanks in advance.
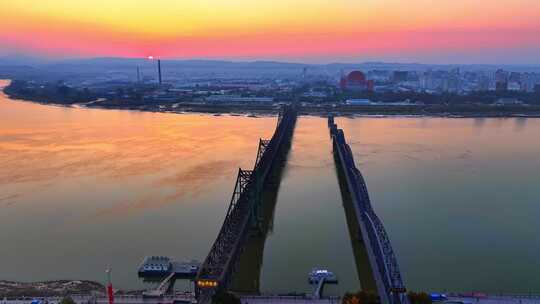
[195,106,297,303]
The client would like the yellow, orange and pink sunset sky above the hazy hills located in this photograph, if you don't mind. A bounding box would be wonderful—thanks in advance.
[0,0,540,64]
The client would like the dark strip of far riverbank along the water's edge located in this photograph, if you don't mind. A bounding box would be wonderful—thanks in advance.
[4,82,540,118]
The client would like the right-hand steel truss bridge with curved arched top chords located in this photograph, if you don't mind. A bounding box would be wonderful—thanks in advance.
[328,116,408,304]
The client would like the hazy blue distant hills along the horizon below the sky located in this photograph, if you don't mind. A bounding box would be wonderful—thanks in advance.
[0,56,540,80]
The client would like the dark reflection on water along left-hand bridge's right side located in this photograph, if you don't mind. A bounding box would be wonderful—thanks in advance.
[230,123,294,295]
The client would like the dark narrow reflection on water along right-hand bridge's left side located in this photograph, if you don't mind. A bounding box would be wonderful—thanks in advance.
[333,144,377,294]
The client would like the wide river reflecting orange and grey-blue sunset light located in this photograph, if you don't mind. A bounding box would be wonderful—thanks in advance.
[0,81,540,294]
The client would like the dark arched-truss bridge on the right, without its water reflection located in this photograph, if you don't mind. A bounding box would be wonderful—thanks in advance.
[328,117,407,303]
